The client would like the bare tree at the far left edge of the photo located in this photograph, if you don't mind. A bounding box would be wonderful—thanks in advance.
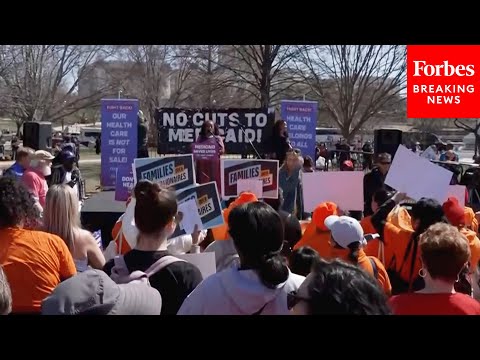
[0,45,119,132]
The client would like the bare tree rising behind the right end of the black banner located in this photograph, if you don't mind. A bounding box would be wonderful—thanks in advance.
[219,45,298,107]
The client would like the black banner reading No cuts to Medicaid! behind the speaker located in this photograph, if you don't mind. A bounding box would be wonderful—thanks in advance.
[155,108,275,154]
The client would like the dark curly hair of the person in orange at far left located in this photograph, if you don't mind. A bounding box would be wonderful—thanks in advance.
[0,176,39,228]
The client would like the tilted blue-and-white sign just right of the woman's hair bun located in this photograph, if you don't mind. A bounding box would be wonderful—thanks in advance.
[171,181,223,238]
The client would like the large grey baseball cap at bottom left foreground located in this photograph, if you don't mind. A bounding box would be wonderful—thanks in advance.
[42,269,162,315]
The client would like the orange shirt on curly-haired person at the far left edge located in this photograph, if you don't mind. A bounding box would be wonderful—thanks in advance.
[0,228,77,313]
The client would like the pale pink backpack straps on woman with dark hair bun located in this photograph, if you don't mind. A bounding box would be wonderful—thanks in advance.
[110,255,186,284]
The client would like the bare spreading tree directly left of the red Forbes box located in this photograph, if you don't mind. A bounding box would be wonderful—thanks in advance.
[296,45,406,138]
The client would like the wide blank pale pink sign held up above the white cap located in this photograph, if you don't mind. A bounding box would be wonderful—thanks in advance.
[302,171,364,212]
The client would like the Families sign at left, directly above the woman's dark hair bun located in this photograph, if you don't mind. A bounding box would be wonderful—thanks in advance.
[133,154,196,191]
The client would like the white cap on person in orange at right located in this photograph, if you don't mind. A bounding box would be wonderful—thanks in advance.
[325,215,366,249]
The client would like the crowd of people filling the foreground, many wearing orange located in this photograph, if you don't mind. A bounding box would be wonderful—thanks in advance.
[0,117,480,315]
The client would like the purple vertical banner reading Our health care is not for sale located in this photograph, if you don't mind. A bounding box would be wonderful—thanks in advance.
[101,99,138,188]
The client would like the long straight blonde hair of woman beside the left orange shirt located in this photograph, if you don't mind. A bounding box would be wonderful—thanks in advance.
[43,185,81,252]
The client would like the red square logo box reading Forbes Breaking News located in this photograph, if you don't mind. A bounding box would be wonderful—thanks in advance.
[407,45,480,118]
